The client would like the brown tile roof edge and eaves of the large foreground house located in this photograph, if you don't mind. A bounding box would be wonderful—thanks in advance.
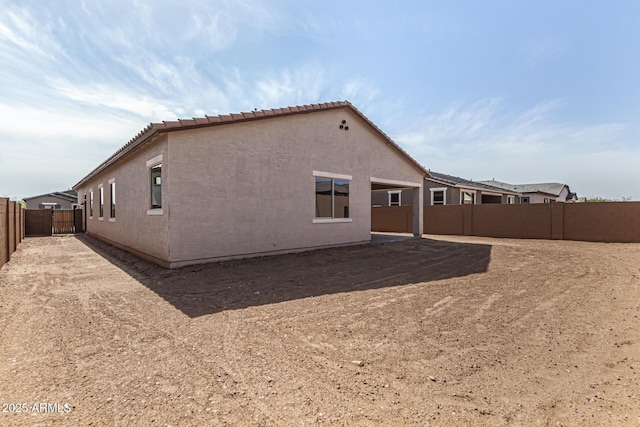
[73,101,430,188]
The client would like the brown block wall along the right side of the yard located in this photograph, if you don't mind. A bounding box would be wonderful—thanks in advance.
[371,202,640,243]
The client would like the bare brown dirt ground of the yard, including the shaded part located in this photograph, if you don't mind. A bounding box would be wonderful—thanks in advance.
[0,236,640,426]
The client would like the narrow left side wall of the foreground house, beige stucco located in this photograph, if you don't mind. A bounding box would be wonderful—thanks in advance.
[76,135,171,266]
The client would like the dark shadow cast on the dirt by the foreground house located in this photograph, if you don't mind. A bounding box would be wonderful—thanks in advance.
[76,234,491,317]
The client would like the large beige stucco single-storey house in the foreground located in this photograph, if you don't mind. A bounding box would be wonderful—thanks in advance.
[73,101,430,268]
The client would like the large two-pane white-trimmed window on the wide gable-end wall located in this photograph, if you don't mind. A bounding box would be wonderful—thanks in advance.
[313,171,352,222]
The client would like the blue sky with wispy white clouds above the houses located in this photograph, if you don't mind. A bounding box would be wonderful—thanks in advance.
[0,0,640,201]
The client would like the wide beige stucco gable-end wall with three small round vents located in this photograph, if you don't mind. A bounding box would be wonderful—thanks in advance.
[167,109,423,266]
